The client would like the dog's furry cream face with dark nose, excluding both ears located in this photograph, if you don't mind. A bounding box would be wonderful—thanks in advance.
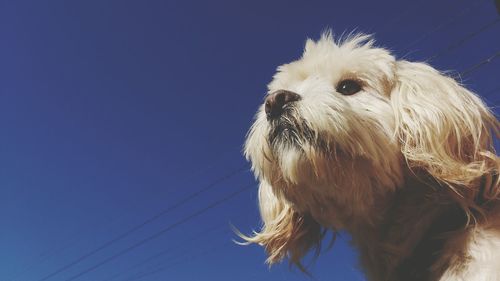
[246,36,402,225]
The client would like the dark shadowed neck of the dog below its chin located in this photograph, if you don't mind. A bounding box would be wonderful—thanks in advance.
[347,175,467,281]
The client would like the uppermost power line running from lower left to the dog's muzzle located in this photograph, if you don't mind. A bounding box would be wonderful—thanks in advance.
[34,164,248,281]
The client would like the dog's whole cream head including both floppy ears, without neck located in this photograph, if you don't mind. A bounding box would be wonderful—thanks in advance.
[241,34,499,263]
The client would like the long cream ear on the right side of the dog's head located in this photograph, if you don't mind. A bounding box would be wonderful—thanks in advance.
[391,61,500,209]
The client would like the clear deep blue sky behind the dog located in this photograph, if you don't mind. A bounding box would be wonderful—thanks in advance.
[0,0,500,281]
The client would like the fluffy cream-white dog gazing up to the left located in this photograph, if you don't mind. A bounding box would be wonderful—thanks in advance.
[240,33,500,281]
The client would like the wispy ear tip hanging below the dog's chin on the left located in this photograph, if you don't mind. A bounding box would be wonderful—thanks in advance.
[240,181,324,269]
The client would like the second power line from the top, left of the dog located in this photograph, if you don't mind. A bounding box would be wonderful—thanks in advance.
[60,184,254,281]
